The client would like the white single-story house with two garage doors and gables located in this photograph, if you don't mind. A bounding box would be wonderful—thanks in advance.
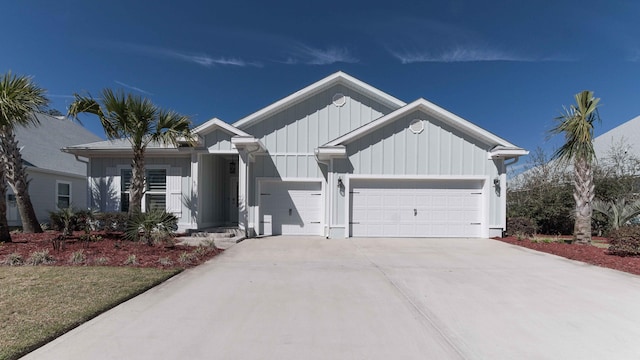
[65,72,528,238]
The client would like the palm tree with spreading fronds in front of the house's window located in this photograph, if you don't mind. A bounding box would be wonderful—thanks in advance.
[69,89,193,217]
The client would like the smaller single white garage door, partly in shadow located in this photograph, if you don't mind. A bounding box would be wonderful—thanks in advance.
[260,181,322,235]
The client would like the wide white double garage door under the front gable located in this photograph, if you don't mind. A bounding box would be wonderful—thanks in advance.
[350,179,483,237]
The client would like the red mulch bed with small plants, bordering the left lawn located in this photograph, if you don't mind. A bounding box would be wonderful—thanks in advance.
[0,231,223,268]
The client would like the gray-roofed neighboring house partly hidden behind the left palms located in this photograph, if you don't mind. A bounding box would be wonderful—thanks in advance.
[7,114,100,226]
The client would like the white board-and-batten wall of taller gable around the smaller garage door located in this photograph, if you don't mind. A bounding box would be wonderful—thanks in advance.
[241,85,392,236]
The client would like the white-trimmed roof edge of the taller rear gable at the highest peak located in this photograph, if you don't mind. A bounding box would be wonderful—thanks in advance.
[233,71,406,128]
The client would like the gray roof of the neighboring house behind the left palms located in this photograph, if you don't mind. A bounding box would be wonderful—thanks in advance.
[15,114,101,176]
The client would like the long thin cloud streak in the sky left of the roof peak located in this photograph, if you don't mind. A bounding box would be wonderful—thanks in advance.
[119,44,262,67]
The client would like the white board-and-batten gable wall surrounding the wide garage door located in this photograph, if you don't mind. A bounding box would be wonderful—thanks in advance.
[329,112,505,237]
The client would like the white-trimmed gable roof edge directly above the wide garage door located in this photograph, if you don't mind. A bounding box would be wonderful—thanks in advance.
[323,98,528,155]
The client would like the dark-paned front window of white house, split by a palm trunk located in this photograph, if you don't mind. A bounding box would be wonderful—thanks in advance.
[120,169,167,212]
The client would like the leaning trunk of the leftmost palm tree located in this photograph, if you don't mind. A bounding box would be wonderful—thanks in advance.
[0,127,42,233]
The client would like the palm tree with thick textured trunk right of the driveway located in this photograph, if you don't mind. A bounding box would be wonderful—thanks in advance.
[549,90,600,244]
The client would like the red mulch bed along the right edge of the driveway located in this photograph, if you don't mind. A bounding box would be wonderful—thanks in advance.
[495,236,640,275]
